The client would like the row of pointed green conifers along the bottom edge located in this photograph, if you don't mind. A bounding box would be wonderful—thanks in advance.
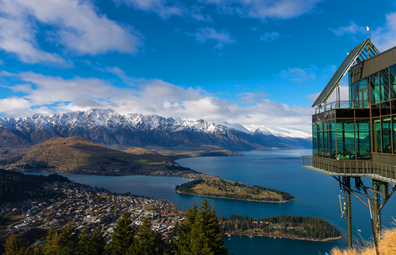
[4,199,228,255]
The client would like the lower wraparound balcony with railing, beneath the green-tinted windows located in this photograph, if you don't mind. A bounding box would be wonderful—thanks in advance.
[301,156,396,185]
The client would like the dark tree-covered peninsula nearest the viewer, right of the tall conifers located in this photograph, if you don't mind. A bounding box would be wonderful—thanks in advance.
[219,215,342,241]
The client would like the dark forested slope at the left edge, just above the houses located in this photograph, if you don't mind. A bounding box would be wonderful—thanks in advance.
[0,169,70,204]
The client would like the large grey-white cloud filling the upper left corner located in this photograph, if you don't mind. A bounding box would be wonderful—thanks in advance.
[0,0,143,65]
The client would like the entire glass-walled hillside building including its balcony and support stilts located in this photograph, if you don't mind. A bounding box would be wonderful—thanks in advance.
[301,39,396,249]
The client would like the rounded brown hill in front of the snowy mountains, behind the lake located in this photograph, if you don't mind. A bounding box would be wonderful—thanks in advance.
[0,137,189,174]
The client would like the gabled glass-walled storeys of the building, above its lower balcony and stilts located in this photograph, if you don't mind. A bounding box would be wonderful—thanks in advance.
[312,39,396,164]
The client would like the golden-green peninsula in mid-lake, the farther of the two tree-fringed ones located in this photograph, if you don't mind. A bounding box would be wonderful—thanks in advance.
[175,177,295,203]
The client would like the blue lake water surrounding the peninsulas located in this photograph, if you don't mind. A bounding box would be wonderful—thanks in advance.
[29,150,396,255]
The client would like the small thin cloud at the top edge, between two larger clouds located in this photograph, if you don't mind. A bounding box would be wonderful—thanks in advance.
[113,0,213,22]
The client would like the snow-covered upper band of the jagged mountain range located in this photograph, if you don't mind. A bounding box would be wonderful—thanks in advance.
[0,108,311,138]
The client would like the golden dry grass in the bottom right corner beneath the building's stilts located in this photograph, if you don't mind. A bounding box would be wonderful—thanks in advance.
[330,229,396,255]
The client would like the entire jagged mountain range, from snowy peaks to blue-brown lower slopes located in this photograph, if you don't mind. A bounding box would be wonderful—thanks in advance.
[0,109,312,150]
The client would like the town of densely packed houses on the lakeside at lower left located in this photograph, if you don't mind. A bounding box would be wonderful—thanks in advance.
[0,179,185,241]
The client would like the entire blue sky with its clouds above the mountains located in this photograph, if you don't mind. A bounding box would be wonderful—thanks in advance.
[0,0,396,132]
